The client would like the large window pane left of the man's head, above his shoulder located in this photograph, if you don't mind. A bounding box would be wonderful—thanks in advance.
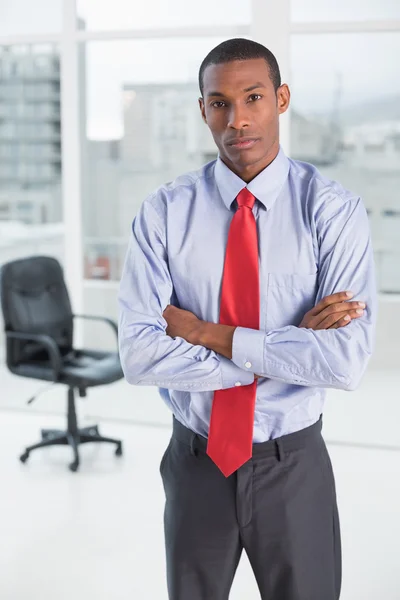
[81,39,222,279]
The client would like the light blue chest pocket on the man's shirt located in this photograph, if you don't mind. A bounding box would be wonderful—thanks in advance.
[265,273,318,330]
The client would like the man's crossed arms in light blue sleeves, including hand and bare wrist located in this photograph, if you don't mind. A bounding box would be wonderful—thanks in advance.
[119,200,376,391]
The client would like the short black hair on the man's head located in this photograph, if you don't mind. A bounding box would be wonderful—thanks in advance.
[199,38,281,96]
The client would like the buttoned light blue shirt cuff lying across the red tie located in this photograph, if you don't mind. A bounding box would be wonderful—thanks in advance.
[232,327,265,375]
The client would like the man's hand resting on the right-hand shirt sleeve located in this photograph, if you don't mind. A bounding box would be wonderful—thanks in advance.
[299,292,365,331]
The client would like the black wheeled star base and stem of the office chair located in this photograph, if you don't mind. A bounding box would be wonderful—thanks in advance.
[19,388,122,472]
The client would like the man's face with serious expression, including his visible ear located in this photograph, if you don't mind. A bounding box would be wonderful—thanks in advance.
[199,58,290,182]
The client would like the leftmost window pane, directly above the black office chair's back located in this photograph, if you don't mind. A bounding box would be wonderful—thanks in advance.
[0,45,62,253]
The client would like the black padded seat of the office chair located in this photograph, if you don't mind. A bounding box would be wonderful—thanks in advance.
[12,350,124,388]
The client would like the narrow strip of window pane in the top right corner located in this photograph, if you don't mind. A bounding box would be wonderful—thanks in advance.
[291,0,400,22]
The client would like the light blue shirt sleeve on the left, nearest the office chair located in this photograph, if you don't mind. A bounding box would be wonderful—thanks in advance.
[118,199,254,391]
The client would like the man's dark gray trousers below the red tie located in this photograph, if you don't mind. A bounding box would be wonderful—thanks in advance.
[160,417,341,600]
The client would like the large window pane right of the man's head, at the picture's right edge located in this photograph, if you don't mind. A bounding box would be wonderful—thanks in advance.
[291,34,400,292]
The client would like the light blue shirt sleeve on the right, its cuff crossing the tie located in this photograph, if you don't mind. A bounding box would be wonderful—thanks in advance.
[232,198,377,390]
